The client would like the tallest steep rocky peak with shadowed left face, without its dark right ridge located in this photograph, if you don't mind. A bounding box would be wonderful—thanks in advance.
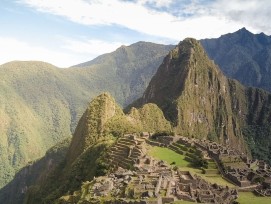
[132,38,249,151]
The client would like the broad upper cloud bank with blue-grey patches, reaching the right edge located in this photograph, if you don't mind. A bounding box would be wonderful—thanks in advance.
[21,0,271,40]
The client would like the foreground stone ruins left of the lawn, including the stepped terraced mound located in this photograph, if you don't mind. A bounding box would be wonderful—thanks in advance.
[73,135,237,204]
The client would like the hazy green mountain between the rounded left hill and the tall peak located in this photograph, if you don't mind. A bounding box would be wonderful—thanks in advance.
[70,42,174,106]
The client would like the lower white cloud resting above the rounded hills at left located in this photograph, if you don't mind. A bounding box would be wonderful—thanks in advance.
[0,36,125,67]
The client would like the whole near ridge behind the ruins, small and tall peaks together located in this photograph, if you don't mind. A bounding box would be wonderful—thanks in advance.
[4,38,271,203]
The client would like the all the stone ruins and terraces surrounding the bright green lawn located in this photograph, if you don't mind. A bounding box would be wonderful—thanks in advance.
[59,133,271,204]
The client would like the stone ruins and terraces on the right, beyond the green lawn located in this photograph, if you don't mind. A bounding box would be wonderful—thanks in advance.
[149,133,271,196]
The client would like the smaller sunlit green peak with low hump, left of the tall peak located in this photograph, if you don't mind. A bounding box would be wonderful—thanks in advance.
[22,93,171,204]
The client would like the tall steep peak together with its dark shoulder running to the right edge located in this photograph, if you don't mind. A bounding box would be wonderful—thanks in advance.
[133,39,271,159]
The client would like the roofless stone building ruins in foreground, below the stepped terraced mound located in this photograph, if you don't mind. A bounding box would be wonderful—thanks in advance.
[79,156,237,204]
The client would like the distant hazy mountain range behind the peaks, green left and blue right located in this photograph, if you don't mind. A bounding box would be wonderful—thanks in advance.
[0,28,271,198]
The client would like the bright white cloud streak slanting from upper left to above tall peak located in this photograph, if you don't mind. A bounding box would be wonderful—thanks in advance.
[18,0,242,41]
